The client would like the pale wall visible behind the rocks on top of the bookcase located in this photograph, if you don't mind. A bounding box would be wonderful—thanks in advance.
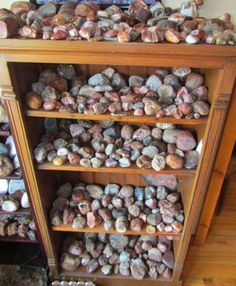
[0,0,236,24]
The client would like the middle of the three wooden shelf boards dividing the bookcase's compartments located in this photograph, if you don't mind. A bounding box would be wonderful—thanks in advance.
[37,163,196,176]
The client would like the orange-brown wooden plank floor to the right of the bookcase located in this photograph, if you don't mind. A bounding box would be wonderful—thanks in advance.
[183,159,236,286]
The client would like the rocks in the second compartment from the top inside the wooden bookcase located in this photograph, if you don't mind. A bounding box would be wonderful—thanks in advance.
[34,120,199,171]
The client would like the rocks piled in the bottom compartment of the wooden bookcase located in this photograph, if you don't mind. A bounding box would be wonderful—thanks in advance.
[61,233,175,280]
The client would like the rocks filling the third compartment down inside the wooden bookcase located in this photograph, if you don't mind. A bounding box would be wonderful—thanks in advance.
[50,183,184,234]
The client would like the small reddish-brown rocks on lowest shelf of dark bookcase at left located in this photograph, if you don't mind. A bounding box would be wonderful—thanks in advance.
[0,214,37,240]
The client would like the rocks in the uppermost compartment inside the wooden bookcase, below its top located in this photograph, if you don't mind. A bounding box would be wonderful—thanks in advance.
[26,65,210,119]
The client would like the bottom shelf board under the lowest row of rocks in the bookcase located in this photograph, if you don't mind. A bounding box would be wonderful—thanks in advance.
[60,267,172,284]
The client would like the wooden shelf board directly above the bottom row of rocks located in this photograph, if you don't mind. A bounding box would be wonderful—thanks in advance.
[51,224,181,237]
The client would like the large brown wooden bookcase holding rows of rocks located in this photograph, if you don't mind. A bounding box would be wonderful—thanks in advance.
[0,39,236,286]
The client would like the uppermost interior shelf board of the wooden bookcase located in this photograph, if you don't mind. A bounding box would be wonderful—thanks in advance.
[26,109,207,125]
